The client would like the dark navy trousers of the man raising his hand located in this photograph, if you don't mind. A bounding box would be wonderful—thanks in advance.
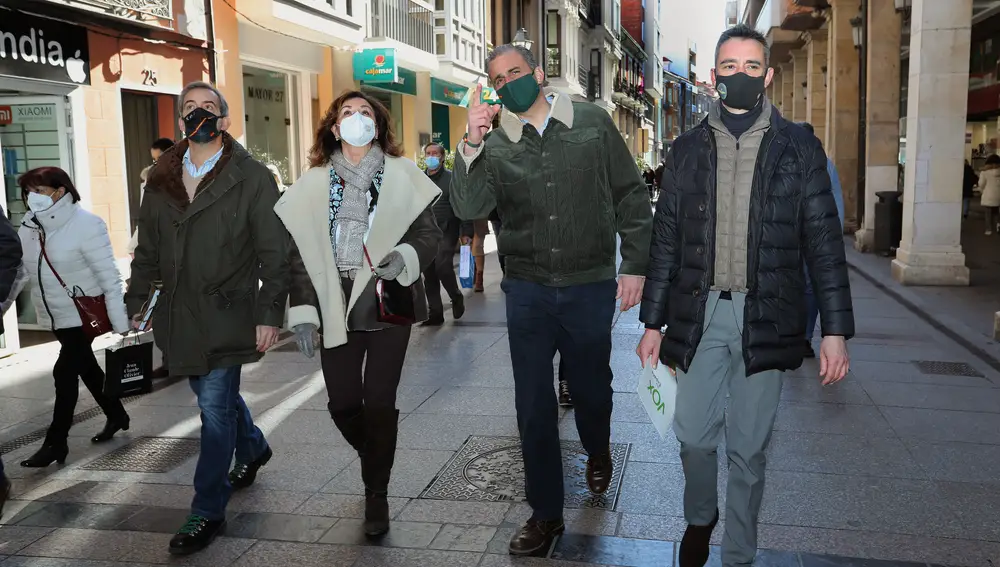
[501,278,618,520]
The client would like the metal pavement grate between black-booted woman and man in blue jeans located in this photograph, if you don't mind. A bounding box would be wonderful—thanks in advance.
[80,437,201,473]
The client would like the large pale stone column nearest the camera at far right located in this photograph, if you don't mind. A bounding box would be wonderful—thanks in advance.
[892,0,972,285]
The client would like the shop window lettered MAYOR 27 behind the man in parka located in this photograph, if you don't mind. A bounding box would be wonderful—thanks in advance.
[243,65,301,185]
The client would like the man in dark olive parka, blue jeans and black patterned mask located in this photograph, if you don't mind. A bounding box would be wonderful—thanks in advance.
[125,83,289,555]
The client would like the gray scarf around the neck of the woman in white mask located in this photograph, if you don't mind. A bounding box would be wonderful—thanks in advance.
[330,145,385,272]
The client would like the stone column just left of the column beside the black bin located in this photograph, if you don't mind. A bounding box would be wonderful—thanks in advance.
[826,0,860,233]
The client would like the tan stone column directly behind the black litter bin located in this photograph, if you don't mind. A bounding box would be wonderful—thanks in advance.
[854,0,903,252]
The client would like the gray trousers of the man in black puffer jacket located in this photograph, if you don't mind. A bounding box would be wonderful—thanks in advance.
[674,291,782,567]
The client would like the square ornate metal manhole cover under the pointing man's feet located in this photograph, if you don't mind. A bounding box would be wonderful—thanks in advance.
[420,435,630,510]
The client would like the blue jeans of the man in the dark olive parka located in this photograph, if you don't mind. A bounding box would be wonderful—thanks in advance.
[190,366,267,520]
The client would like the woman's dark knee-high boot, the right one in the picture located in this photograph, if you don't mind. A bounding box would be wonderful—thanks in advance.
[361,408,399,537]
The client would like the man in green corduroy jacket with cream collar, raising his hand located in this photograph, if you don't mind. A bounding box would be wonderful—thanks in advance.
[451,45,653,555]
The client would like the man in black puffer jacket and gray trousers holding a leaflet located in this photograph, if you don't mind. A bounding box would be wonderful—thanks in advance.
[637,25,854,567]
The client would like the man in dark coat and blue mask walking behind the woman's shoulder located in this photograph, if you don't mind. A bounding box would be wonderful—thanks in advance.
[424,142,465,326]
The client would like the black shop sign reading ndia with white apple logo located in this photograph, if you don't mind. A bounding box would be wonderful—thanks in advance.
[0,10,90,85]
